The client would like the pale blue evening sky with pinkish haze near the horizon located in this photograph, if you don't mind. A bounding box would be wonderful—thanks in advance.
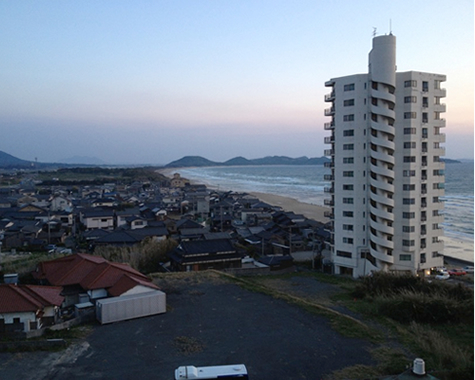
[0,0,474,164]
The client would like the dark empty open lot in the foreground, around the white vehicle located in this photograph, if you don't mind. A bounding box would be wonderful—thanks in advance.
[0,275,380,380]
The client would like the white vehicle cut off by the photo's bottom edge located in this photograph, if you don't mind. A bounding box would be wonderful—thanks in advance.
[175,364,249,380]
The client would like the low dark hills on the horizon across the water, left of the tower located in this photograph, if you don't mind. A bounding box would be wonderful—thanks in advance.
[165,156,330,168]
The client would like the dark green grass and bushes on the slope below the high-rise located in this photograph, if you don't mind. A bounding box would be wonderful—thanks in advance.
[225,272,474,380]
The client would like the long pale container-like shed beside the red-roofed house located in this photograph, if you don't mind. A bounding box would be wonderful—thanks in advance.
[96,290,167,324]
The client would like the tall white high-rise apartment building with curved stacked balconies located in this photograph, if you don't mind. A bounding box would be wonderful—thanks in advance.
[325,34,446,277]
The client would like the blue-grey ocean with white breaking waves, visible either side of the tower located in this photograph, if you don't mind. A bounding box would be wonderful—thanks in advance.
[176,162,474,261]
